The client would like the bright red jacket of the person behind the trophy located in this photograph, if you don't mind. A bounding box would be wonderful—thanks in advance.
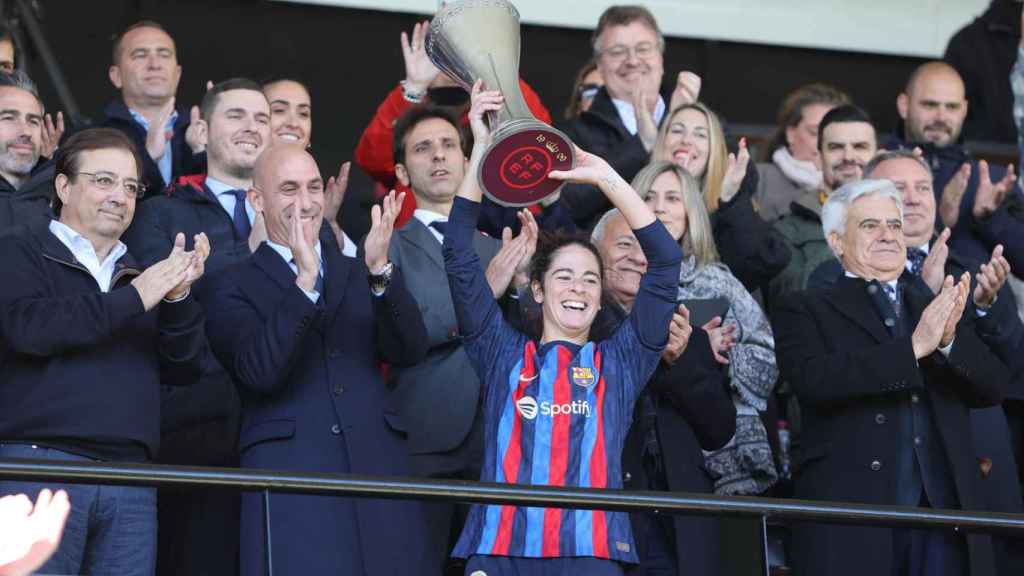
[355,79,551,228]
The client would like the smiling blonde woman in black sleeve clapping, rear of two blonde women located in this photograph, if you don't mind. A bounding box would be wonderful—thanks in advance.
[652,102,790,292]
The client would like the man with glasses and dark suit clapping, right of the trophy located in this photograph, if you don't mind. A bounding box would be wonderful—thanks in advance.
[562,6,700,230]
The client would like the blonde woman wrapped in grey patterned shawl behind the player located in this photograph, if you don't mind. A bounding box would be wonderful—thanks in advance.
[633,161,778,494]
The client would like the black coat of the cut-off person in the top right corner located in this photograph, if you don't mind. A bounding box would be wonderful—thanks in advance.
[943,0,1021,142]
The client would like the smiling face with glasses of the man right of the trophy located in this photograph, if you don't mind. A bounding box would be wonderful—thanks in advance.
[597,20,665,102]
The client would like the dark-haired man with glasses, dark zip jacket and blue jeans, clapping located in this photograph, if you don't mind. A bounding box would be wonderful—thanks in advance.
[0,128,210,574]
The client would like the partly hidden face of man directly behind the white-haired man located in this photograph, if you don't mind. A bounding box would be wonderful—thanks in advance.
[871,158,936,248]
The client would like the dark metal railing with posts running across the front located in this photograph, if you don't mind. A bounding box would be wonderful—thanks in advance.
[0,459,1024,572]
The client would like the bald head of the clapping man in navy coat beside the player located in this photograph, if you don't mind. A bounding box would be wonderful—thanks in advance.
[249,145,324,247]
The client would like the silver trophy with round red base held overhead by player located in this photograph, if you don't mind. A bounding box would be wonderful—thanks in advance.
[426,0,575,206]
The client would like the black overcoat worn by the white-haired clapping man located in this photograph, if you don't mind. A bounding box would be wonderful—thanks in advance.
[773,275,1008,576]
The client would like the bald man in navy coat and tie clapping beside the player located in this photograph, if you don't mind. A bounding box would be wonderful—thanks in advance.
[204,145,427,576]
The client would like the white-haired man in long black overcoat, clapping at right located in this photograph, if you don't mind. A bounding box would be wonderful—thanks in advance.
[773,179,1008,576]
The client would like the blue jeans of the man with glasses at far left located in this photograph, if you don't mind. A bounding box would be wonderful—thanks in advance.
[0,444,157,576]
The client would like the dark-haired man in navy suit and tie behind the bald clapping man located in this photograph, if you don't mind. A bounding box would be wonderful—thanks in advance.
[125,78,270,574]
